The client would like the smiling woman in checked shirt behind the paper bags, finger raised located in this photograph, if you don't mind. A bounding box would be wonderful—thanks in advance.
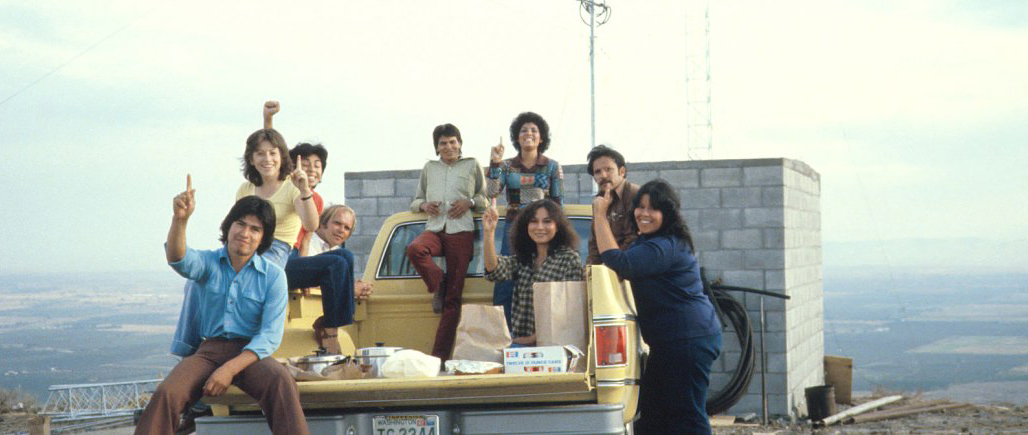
[482,200,582,347]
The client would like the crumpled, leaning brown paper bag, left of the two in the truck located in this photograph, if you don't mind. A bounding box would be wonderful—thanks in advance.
[452,303,511,363]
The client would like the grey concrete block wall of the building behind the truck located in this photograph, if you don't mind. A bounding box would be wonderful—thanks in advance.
[345,158,823,416]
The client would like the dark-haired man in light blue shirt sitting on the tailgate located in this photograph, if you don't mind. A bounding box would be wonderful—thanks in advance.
[136,176,308,434]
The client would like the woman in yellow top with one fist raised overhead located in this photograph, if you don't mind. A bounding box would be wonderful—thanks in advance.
[235,129,318,268]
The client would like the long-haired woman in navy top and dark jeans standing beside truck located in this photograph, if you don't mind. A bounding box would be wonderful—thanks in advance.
[592,179,721,434]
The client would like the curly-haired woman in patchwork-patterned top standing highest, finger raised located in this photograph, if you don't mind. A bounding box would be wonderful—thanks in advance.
[485,112,564,324]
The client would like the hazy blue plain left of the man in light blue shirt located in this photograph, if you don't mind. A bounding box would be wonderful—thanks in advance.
[0,270,183,404]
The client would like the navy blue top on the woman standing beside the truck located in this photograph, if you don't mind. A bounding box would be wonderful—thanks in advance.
[599,234,721,345]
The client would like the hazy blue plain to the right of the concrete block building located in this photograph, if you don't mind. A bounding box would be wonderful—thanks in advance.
[824,271,1028,400]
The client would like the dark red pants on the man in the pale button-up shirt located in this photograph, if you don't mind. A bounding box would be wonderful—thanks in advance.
[407,231,475,361]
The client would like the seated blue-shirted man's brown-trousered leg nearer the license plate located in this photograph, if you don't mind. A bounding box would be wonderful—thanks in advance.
[232,351,309,434]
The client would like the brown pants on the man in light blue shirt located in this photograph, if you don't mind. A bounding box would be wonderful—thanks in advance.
[136,338,309,435]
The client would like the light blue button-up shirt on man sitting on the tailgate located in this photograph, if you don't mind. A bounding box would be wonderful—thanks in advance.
[169,247,288,359]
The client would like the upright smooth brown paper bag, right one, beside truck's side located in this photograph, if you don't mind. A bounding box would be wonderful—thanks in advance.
[533,281,589,351]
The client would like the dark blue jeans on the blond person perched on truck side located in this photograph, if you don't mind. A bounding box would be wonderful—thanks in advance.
[286,248,357,328]
